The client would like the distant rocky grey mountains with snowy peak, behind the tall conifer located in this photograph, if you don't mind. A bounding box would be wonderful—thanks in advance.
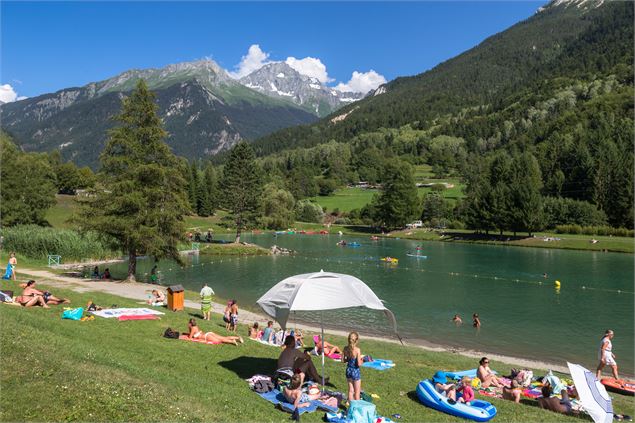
[0,59,362,168]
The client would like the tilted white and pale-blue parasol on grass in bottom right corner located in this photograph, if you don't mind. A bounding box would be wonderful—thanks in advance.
[567,362,613,423]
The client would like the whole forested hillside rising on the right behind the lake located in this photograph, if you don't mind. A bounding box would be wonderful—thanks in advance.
[246,0,634,231]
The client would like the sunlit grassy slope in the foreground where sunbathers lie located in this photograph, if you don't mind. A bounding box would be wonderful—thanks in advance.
[0,282,633,422]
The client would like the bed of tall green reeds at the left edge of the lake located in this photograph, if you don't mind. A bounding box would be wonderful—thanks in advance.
[0,225,121,260]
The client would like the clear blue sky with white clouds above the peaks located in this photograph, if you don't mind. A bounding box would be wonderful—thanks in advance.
[0,0,545,102]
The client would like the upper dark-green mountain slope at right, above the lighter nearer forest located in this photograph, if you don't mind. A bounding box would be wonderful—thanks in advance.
[250,0,633,155]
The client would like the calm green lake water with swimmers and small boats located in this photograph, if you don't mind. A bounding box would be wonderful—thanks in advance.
[111,234,635,375]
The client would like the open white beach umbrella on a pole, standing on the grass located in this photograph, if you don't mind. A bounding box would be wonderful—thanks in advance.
[257,270,401,386]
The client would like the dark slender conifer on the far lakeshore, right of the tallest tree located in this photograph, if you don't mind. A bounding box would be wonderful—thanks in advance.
[220,142,262,243]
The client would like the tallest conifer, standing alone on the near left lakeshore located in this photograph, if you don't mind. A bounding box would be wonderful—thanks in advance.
[78,80,188,280]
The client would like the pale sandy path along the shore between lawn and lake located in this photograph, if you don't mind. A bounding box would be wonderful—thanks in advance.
[19,268,592,377]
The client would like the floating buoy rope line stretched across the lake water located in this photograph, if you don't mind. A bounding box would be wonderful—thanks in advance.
[168,255,635,294]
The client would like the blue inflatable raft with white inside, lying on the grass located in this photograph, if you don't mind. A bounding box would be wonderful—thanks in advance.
[417,379,496,422]
